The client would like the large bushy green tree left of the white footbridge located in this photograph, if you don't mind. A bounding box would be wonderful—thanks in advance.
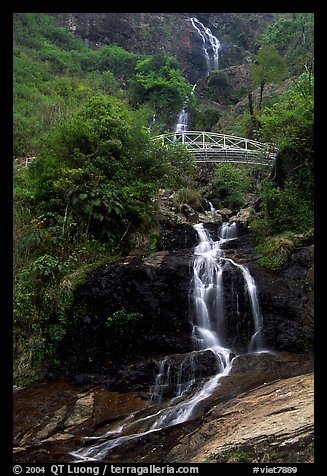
[28,94,196,246]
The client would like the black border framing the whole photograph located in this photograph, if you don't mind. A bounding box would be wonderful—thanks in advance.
[7,1,327,475]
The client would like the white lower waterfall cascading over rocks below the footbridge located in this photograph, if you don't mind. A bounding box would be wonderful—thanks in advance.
[70,222,265,461]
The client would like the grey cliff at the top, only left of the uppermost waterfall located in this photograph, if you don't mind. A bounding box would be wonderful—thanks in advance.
[51,13,206,80]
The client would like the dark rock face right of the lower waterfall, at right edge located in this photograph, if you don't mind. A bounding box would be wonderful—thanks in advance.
[250,245,314,352]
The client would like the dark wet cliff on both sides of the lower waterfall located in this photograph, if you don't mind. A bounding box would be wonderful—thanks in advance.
[54,218,313,390]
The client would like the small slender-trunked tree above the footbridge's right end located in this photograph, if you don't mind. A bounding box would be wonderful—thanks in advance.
[251,45,286,110]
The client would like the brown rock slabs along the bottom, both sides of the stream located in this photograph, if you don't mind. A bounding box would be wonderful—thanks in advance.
[13,353,314,464]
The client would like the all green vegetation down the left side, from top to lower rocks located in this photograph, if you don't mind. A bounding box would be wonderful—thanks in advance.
[14,13,194,383]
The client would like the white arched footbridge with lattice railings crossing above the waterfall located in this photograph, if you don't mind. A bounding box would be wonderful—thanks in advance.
[154,131,278,167]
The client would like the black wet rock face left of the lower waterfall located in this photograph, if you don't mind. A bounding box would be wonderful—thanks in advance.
[58,252,192,384]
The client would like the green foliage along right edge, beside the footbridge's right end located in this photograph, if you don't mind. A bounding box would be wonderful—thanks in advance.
[251,69,314,269]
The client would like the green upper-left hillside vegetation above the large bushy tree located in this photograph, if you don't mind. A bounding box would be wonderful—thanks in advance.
[14,13,192,156]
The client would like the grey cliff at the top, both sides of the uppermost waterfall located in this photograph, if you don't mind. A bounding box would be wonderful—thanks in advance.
[51,13,280,83]
